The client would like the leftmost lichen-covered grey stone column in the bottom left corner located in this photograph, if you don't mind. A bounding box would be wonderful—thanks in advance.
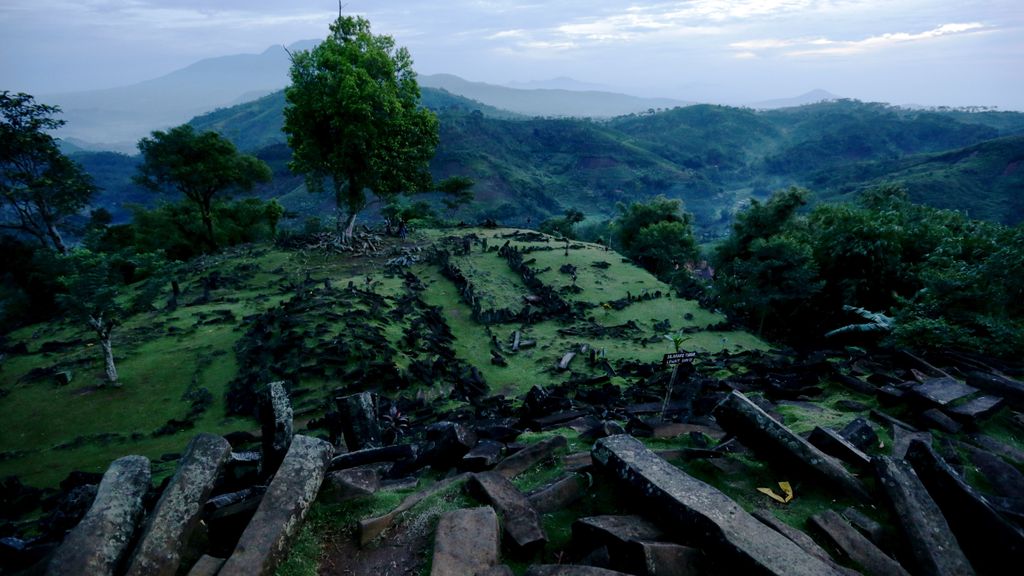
[46,456,150,576]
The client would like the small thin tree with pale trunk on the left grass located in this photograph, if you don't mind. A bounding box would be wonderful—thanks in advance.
[58,249,124,385]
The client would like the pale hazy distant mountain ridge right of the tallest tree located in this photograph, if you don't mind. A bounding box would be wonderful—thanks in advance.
[420,74,692,118]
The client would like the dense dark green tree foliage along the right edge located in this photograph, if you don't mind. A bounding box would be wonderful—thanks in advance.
[715,186,1024,355]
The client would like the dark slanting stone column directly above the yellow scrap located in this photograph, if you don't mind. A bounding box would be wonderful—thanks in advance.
[716,392,870,502]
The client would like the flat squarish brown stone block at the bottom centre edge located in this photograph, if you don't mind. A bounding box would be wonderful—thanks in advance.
[430,506,501,576]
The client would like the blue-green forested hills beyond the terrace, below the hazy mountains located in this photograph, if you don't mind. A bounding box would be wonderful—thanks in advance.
[79,88,1024,233]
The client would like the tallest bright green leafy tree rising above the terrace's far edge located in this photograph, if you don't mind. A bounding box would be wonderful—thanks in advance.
[284,16,438,242]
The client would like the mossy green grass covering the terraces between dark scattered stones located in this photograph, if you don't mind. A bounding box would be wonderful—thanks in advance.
[0,230,764,486]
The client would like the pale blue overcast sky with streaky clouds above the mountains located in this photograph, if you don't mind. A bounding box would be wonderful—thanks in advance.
[0,0,1024,111]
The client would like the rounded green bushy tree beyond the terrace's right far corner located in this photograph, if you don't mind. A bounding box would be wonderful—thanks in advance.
[614,196,697,276]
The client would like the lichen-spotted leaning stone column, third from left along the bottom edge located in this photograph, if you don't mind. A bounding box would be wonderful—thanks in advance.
[219,435,334,576]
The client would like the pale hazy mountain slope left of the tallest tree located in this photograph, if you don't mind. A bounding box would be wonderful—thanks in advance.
[43,41,313,153]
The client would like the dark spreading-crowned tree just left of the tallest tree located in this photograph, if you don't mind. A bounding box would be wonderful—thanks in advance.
[135,124,271,250]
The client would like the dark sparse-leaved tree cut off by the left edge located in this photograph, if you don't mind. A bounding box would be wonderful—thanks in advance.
[0,90,96,253]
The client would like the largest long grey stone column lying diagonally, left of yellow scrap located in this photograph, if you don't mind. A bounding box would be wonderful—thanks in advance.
[593,436,837,576]
